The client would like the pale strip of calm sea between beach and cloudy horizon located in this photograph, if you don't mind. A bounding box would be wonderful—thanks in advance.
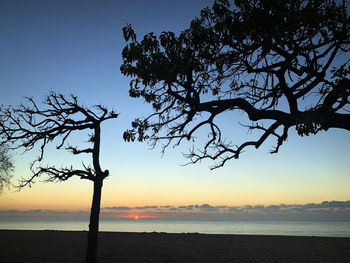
[0,217,350,237]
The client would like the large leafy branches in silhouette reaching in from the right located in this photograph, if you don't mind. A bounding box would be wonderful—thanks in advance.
[121,0,350,168]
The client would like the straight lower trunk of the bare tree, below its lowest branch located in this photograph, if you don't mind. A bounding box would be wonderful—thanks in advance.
[85,177,103,263]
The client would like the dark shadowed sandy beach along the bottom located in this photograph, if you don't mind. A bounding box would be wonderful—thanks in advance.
[0,230,350,263]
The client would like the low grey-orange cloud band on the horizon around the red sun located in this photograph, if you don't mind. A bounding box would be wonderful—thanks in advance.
[0,201,350,221]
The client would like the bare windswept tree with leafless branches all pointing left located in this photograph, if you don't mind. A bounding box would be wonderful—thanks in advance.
[0,93,118,262]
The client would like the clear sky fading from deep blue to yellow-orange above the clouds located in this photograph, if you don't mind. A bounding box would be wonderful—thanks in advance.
[0,0,350,222]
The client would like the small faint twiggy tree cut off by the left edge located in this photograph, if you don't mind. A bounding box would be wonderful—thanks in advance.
[0,145,14,193]
